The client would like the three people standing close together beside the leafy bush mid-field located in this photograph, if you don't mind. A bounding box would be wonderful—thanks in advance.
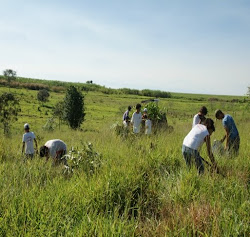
[123,104,152,135]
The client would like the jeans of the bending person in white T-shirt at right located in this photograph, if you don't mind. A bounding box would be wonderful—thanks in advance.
[182,145,204,174]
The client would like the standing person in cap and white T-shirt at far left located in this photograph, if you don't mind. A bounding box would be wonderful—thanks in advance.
[22,123,37,159]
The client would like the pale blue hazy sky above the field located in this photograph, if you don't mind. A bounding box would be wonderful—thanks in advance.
[0,0,250,95]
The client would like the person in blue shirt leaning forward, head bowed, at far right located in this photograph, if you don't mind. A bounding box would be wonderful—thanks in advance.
[215,109,240,156]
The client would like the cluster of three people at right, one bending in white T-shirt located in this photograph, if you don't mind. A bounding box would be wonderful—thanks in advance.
[182,106,240,173]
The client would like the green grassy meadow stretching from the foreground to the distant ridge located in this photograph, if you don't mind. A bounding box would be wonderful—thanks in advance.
[0,84,250,236]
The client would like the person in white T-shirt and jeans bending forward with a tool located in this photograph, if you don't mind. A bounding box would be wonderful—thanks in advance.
[182,118,217,174]
